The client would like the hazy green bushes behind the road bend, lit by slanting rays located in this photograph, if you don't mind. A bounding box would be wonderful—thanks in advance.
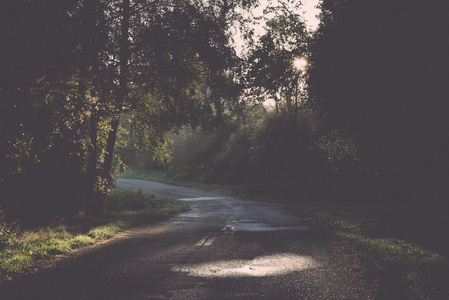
[131,105,348,199]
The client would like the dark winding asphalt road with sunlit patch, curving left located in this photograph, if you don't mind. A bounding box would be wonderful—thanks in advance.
[0,179,373,300]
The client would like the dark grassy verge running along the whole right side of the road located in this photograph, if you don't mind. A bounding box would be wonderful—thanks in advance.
[124,171,449,299]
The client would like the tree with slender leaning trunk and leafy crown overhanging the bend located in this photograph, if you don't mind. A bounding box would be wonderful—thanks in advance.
[92,1,245,210]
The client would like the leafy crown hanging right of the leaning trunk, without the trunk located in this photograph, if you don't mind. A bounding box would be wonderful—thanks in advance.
[114,2,243,163]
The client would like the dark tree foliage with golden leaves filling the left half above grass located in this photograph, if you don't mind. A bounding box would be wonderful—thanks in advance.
[0,0,245,220]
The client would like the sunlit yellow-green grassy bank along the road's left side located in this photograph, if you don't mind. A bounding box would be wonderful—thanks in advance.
[0,189,190,283]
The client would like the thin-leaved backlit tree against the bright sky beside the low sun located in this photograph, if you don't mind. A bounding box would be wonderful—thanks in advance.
[246,2,309,120]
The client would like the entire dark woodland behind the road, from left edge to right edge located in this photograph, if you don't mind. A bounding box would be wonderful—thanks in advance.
[0,0,449,252]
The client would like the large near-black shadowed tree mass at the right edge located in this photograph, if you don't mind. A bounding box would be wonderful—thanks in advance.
[308,0,449,213]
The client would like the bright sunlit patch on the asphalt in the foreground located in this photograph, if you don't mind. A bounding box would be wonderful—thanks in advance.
[173,253,317,278]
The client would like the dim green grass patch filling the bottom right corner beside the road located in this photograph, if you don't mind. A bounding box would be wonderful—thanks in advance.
[336,231,449,299]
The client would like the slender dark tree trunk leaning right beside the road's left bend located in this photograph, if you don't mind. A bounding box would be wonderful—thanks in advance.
[95,0,130,214]
